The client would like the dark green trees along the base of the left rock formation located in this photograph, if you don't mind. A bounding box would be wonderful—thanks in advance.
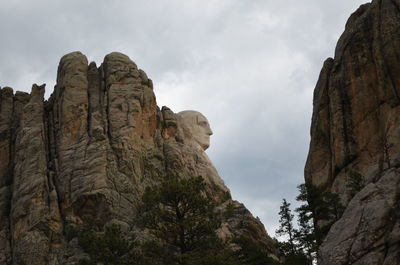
[70,177,278,265]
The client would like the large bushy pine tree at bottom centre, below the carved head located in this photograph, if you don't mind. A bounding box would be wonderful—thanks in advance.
[141,176,235,265]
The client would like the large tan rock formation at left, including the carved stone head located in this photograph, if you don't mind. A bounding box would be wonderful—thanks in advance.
[0,52,278,265]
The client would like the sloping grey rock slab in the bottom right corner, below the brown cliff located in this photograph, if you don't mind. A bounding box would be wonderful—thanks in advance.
[320,168,400,265]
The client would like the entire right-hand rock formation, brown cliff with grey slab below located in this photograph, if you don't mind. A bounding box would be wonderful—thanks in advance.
[305,0,400,265]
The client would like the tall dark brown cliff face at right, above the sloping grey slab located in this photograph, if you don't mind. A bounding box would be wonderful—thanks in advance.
[305,0,400,190]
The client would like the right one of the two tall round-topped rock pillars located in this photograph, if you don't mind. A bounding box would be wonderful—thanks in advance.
[104,53,148,179]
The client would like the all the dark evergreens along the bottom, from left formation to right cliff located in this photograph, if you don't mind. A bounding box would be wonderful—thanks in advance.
[70,172,364,265]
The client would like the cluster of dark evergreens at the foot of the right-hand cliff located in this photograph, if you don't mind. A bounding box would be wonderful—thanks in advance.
[275,170,365,265]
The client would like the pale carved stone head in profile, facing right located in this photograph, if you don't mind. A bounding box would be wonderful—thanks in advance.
[178,110,213,150]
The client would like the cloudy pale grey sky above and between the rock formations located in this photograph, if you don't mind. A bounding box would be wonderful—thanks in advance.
[0,0,368,236]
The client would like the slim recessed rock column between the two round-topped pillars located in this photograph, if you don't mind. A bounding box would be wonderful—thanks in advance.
[71,59,111,223]
